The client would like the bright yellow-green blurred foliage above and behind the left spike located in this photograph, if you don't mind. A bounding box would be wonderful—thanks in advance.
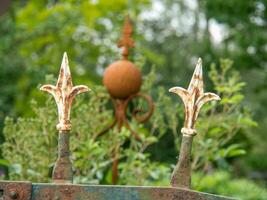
[15,0,147,113]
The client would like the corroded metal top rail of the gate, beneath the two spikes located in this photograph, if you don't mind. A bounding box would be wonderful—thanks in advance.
[0,182,237,200]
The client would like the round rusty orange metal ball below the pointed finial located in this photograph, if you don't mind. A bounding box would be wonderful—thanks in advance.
[103,60,142,99]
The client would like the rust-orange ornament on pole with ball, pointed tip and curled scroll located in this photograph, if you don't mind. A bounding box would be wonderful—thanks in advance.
[98,16,154,184]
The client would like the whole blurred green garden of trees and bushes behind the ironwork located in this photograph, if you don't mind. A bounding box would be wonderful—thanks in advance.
[0,0,267,199]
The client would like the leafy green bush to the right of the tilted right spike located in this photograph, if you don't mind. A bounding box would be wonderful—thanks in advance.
[192,59,257,171]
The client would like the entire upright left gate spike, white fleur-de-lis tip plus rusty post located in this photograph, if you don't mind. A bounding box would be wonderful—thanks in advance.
[40,52,89,183]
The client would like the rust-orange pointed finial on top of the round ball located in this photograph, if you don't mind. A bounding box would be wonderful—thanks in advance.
[118,15,134,60]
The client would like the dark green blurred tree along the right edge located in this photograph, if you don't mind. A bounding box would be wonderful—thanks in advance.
[200,0,267,175]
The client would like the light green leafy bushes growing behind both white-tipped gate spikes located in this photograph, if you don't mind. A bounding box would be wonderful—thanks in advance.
[2,60,256,188]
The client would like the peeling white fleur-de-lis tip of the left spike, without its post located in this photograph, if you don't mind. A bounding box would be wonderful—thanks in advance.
[40,52,89,131]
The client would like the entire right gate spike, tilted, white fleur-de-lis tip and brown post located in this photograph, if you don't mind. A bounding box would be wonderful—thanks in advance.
[169,58,220,188]
